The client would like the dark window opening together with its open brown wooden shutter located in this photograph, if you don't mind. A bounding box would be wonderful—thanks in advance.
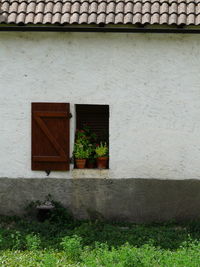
[31,103,109,174]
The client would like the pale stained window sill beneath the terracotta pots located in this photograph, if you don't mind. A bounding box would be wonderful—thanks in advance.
[72,169,109,179]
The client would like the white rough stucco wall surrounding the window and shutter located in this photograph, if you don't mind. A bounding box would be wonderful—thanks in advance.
[0,33,200,179]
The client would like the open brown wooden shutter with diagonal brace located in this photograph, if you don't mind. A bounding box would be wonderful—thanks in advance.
[32,103,70,171]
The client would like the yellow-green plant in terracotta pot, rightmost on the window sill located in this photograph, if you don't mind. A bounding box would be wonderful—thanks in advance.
[95,142,108,169]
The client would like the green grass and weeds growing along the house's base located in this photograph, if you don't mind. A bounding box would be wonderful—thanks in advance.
[0,204,200,267]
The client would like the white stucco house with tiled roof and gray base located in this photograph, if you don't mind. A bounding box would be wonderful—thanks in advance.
[0,0,200,222]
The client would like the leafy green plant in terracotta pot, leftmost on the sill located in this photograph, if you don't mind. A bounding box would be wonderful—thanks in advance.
[74,143,89,169]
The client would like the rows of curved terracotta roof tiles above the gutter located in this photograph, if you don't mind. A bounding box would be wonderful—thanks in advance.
[0,0,200,25]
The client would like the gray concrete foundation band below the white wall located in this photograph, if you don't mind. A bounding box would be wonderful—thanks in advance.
[0,178,200,223]
